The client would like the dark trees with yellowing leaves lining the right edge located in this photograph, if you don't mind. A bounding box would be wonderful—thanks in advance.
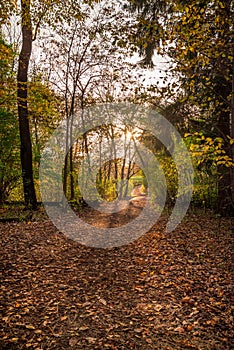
[130,0,234,215]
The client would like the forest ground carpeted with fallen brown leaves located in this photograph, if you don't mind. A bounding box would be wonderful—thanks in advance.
[0,205,234,350]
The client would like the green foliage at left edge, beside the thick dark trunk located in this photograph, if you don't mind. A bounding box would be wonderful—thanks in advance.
[0,38,21,202]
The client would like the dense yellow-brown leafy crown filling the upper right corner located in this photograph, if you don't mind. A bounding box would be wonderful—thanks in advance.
[167,0,233,120]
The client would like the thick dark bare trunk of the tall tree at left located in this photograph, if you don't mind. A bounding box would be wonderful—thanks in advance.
[17,0,37,209]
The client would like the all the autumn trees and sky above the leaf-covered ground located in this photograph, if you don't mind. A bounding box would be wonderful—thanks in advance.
[0,0,234,215]
